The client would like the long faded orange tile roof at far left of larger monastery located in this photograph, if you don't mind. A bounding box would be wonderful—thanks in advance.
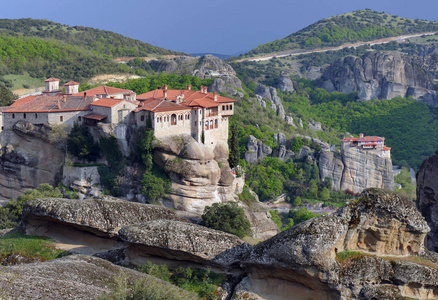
[5,94,93,113]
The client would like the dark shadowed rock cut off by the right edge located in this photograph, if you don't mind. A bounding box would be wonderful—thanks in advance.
[417,152,438,252]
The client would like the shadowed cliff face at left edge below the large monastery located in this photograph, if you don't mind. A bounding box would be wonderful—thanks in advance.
[0,122,65,198]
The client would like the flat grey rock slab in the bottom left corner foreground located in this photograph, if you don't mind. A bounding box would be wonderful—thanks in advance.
[0,255,193,299]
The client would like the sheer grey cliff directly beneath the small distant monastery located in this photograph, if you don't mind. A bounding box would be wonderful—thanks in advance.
[319,147,394,193]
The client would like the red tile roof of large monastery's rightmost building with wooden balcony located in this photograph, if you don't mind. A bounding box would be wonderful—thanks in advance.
[137,89,236,107]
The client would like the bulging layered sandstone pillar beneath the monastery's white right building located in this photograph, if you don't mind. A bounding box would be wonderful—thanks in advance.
[154,135,237,215]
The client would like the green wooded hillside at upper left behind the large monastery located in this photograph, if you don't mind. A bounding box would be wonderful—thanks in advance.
[0,19,181,88]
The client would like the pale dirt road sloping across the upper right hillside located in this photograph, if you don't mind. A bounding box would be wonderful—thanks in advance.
[235,31,438,62]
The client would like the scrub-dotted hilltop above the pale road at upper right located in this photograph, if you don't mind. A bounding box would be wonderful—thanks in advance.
[245,9,438,56]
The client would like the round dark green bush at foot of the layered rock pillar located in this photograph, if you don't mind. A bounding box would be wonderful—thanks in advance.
[201,202,251,238]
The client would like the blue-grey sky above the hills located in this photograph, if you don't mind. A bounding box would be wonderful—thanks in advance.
[0,0,438,54]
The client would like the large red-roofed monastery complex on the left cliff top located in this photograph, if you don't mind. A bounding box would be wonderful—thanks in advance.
[0,78,235,146]
